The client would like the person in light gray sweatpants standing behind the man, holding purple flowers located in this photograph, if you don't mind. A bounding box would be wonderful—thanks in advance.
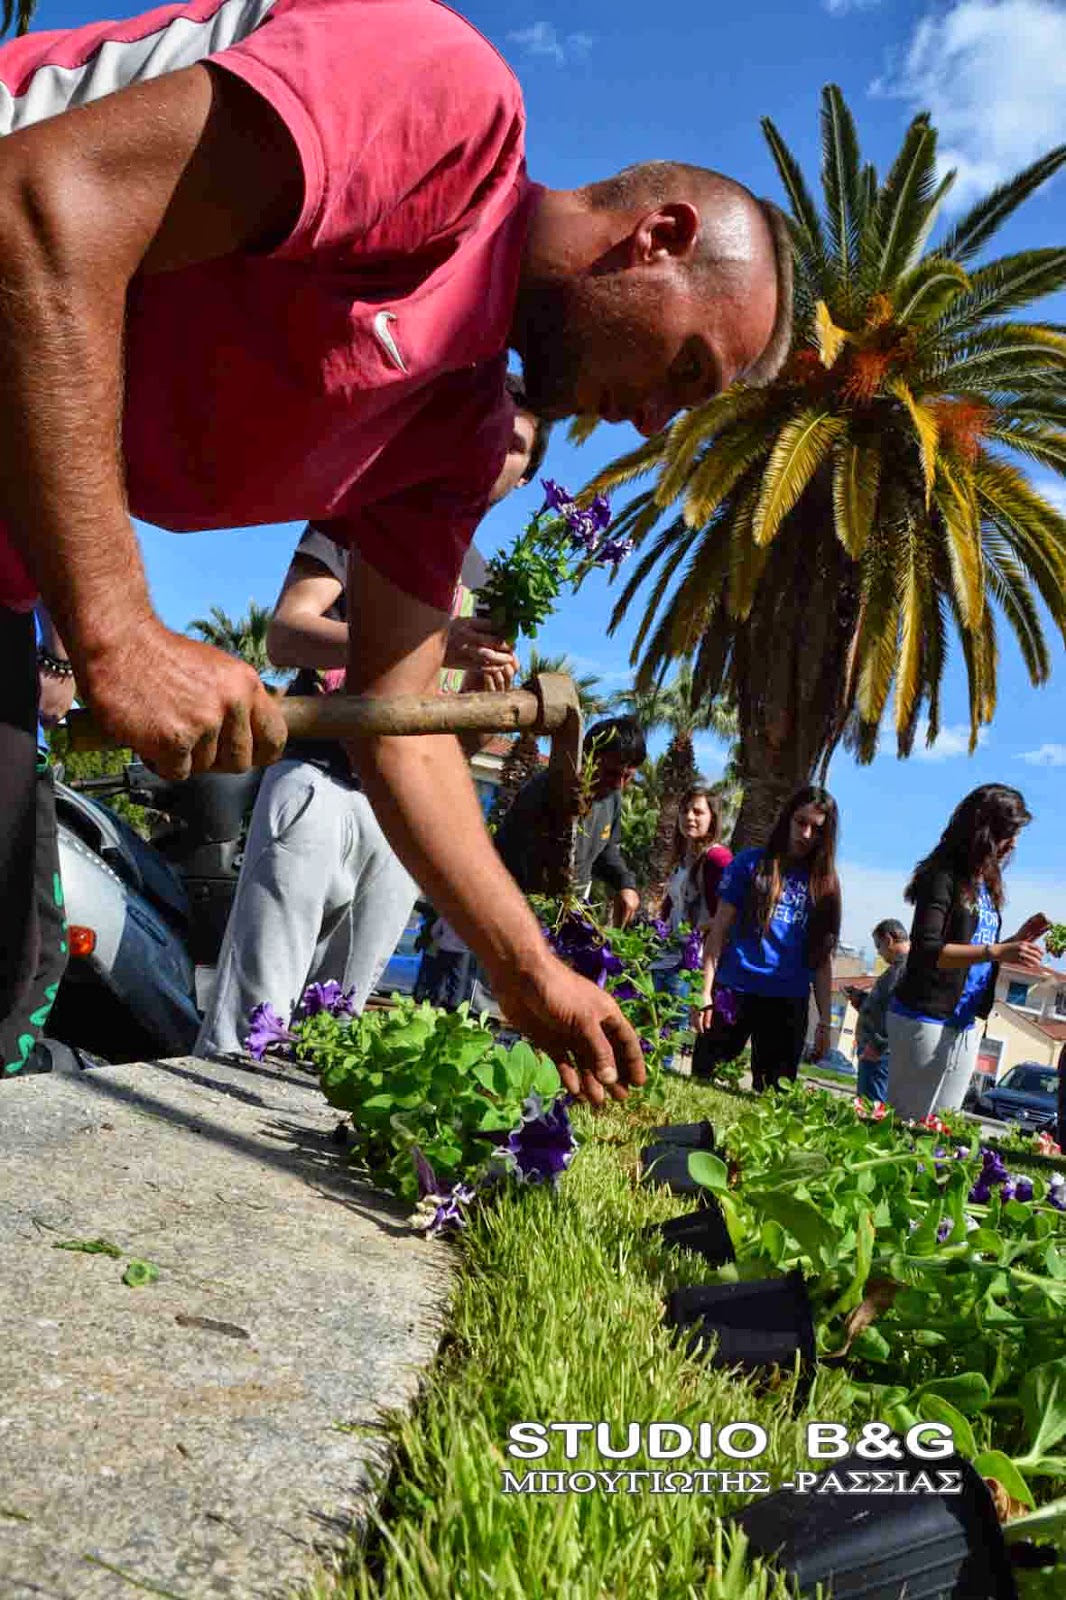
[194,379,547,1058]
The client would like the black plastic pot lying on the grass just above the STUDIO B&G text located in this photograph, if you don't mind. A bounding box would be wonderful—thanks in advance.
[666,1272,815,1371]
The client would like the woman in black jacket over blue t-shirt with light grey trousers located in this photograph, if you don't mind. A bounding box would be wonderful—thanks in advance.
[887,784,1050,1118]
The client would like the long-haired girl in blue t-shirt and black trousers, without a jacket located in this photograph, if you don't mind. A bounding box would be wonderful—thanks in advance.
[691,786,840,1091]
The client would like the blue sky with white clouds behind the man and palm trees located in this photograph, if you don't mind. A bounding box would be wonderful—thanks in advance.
[37,0,1066,944]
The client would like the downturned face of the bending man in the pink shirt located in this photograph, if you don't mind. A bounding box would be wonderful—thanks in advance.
[523,232,776,437]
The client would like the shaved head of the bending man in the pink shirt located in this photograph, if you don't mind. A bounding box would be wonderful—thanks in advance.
[515,162,792,434]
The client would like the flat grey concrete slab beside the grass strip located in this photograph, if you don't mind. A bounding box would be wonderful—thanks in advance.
[0,1058,450,1600]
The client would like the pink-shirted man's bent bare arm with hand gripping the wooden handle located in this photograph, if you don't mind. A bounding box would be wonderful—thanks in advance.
[0,67,303,776]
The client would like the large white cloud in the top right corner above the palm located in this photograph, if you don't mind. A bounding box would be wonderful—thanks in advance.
[874,0,1066,206]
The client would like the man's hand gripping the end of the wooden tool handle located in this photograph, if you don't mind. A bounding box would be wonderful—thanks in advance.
[80,618,288,779]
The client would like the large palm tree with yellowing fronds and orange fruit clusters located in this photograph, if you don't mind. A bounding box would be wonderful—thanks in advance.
[591,86,1066,845]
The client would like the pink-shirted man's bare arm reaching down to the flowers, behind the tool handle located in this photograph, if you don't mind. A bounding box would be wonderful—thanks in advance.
[347,557,645,1101]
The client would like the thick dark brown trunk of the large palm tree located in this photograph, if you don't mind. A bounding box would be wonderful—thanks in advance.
[731,486,860,850]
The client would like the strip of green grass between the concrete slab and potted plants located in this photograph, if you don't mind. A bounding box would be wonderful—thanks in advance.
[305,1083,860,1600]
